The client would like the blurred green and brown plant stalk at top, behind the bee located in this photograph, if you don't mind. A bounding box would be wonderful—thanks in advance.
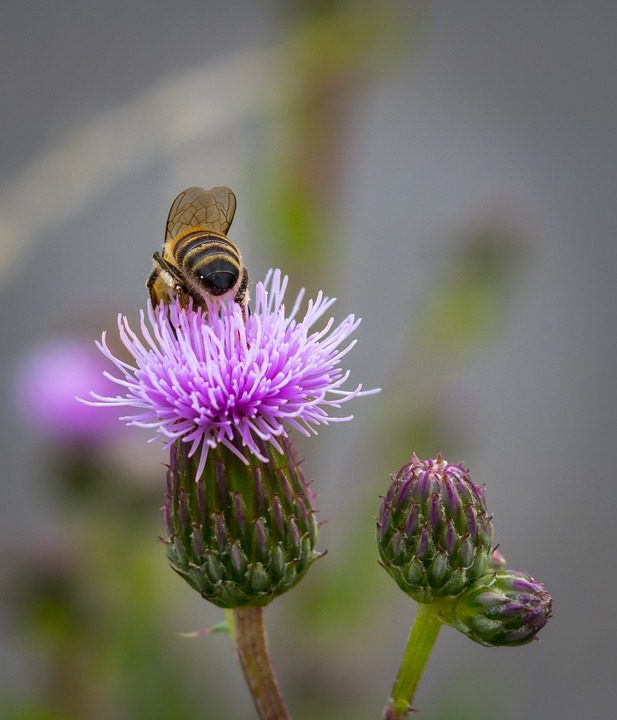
[253,2,406,291]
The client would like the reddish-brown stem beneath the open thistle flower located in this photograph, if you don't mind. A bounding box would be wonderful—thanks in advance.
[228,607,289,720]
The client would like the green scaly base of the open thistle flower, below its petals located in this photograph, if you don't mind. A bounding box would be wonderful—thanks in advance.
[163,438,319,608]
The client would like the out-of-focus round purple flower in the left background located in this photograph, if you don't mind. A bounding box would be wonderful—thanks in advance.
[15,339,118,443]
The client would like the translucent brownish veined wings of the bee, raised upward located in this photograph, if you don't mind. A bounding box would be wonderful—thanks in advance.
[165,186,236,242]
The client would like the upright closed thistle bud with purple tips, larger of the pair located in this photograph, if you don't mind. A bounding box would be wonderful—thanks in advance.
[377,453,493,603]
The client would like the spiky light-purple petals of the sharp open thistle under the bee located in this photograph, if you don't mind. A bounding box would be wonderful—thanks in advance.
[87,270,376,478]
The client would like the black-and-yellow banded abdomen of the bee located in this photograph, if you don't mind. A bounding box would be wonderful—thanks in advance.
[174,231,242,295]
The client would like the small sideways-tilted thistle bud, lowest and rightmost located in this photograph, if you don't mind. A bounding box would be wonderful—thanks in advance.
[440,570,552,647]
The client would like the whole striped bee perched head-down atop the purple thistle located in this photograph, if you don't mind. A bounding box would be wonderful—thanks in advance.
[146,187,249,312]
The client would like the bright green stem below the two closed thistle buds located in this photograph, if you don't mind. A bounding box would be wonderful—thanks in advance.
[383,604,441,720]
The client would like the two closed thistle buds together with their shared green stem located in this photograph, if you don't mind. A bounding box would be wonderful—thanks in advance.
[377,453,552,720]
